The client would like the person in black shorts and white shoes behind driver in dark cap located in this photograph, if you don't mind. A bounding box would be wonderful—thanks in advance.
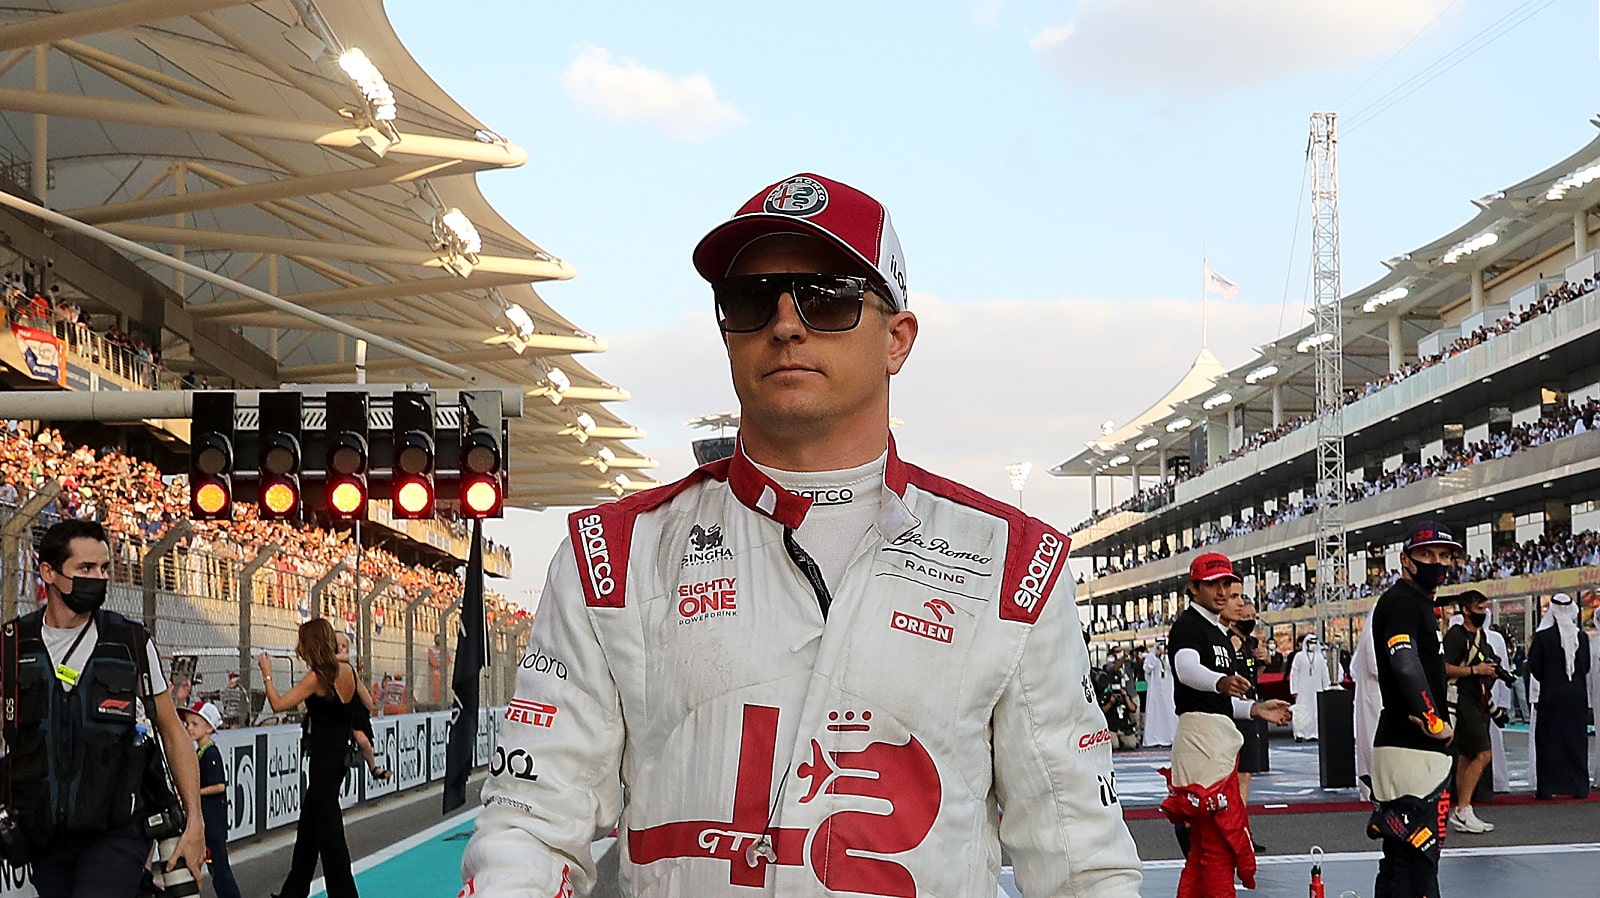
[1445,589,1506,832]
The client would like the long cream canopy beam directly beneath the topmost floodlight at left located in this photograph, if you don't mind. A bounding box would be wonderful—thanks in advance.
[0,85,528,168]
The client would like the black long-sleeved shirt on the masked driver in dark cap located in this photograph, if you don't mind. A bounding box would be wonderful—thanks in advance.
[1373,579,1450,754]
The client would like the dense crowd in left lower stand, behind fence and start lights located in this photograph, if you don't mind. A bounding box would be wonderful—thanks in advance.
[0,421,522,633]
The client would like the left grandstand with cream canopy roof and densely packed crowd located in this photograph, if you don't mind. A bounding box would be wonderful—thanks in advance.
[0,0,654,708]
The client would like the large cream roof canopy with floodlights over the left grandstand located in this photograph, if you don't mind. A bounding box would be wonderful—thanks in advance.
[0,0,654,507]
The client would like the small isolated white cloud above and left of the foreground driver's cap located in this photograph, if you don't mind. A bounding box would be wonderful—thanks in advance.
[562,46,744,142]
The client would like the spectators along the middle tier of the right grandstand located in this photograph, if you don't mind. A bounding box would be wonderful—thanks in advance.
[1098,399,1600,575]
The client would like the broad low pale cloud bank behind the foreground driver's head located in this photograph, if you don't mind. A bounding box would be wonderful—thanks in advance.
[491,293,1280,608]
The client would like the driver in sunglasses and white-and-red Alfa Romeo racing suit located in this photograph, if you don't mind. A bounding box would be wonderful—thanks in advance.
[462,174,1141,898]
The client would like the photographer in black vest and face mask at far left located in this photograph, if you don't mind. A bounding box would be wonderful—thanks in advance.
[0,520,205,898]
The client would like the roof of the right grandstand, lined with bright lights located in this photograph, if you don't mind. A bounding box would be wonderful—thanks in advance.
[1050,118,1600,477]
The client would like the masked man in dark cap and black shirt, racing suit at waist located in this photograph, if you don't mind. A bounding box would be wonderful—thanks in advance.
[1366,520,1461,898]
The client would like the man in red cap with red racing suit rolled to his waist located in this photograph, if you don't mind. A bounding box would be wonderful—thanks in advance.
[1162,552,1290,898]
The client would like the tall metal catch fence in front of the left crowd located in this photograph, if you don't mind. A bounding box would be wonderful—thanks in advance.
[0,482,528,725]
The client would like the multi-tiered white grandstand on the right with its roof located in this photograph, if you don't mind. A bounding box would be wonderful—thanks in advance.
[1051,124,1600,651]
